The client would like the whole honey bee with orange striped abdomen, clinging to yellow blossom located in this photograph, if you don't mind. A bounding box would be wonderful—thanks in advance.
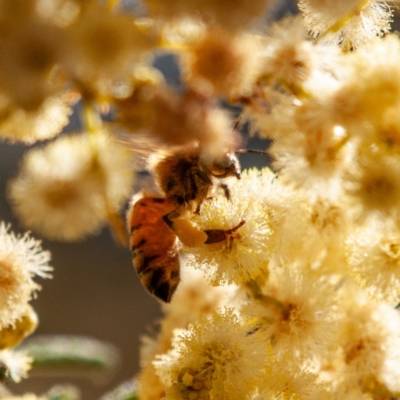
[128,147,244,303]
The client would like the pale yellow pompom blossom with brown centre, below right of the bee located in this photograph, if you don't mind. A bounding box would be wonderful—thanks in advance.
[244,265,338,360]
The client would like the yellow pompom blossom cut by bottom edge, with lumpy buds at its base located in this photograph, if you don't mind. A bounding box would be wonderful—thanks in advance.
[154,309,273,400]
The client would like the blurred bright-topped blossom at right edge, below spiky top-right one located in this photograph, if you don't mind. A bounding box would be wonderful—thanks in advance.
[321,35,400,130]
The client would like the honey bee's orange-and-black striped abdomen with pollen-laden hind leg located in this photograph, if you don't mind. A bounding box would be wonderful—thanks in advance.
[128,192,245,303]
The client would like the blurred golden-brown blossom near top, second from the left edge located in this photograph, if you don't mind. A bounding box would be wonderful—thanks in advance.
[64,3,156,91]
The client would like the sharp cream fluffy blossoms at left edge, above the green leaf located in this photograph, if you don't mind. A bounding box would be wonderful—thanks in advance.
[0,222,52,382]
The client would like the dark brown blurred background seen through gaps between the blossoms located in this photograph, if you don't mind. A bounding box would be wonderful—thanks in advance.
[0,0,295,400]
